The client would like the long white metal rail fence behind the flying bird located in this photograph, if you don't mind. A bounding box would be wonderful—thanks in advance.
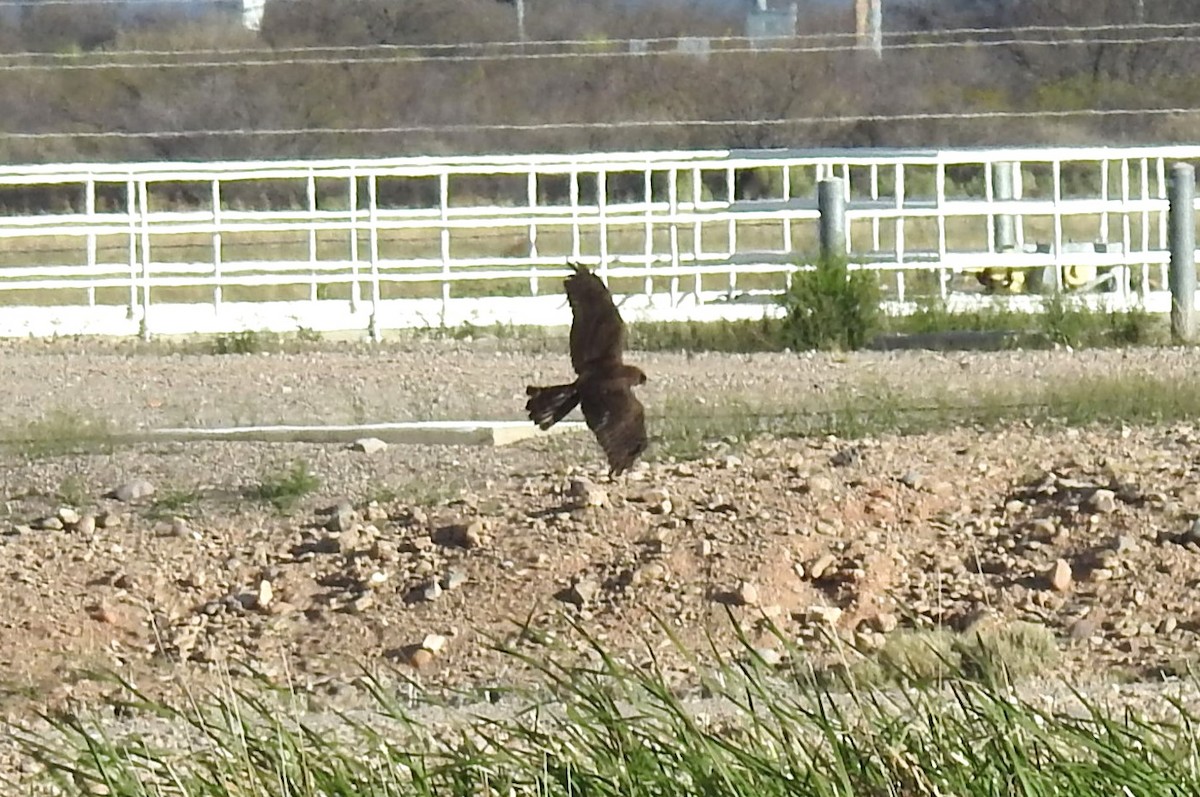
[0,146,1200,336]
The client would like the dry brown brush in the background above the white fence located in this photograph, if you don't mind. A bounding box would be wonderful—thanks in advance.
[0,0,1200,162]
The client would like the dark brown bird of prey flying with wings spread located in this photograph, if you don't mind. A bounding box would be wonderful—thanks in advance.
[526,263,647,477]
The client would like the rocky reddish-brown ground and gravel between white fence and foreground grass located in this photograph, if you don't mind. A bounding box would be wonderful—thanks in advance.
[0,341,1200,772]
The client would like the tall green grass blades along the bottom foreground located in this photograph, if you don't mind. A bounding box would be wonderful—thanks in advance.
[10,614,1200,797]
